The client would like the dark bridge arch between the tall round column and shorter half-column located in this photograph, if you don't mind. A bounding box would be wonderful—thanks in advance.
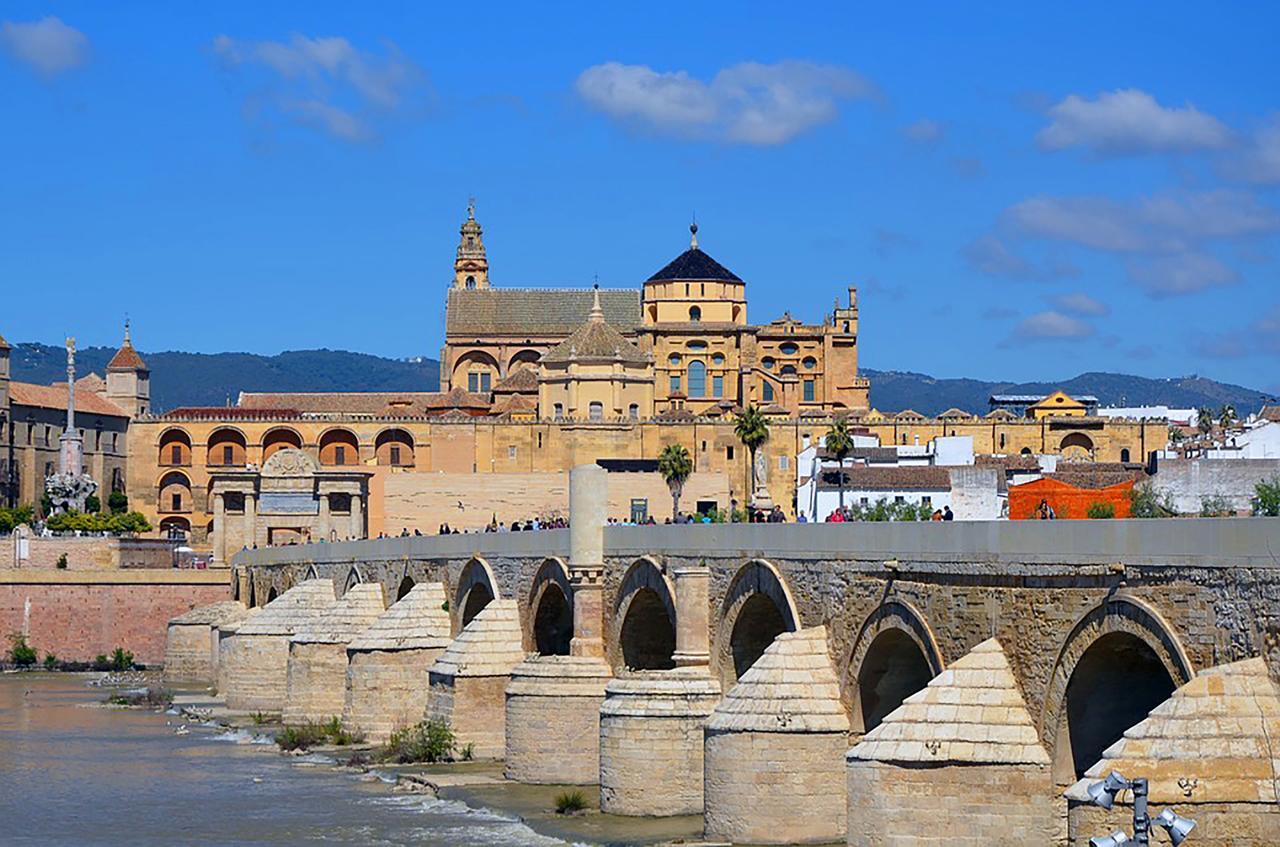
[613,557,676,670]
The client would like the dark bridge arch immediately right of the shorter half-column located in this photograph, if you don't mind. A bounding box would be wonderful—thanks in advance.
[716,559,800,691]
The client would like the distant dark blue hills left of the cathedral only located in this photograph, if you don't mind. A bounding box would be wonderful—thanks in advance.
[10,344,440,411]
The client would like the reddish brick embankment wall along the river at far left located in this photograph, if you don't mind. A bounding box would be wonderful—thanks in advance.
[0,569,229,665]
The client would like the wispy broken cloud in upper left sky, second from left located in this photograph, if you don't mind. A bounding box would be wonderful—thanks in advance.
[212,33,430,142]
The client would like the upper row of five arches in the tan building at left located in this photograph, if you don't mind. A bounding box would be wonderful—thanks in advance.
[159,426,415,467]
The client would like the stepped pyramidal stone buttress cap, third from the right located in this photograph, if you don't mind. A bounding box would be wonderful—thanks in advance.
[707,627,849,732]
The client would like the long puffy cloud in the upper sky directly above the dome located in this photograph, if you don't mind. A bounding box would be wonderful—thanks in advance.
[575,61,876,145]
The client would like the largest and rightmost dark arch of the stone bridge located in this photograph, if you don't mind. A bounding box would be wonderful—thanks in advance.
[1039,595,1196,784]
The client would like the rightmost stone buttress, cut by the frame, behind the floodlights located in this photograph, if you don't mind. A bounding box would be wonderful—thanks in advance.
[1066,658,1280,847]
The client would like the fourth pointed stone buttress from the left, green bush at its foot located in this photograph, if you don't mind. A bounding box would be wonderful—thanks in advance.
[342,582,451,743]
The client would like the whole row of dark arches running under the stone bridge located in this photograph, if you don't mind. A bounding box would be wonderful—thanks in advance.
[257,557,1194,784]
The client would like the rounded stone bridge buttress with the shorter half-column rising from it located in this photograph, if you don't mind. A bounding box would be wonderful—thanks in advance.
[600,566,721,816]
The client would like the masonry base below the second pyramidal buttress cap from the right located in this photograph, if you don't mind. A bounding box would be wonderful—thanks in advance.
[849,761,1059,847]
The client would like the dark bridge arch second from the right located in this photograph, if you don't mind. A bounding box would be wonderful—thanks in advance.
[841,599,946,733]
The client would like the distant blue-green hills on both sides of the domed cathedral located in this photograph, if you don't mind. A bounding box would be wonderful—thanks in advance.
[12,344,1274,415]
